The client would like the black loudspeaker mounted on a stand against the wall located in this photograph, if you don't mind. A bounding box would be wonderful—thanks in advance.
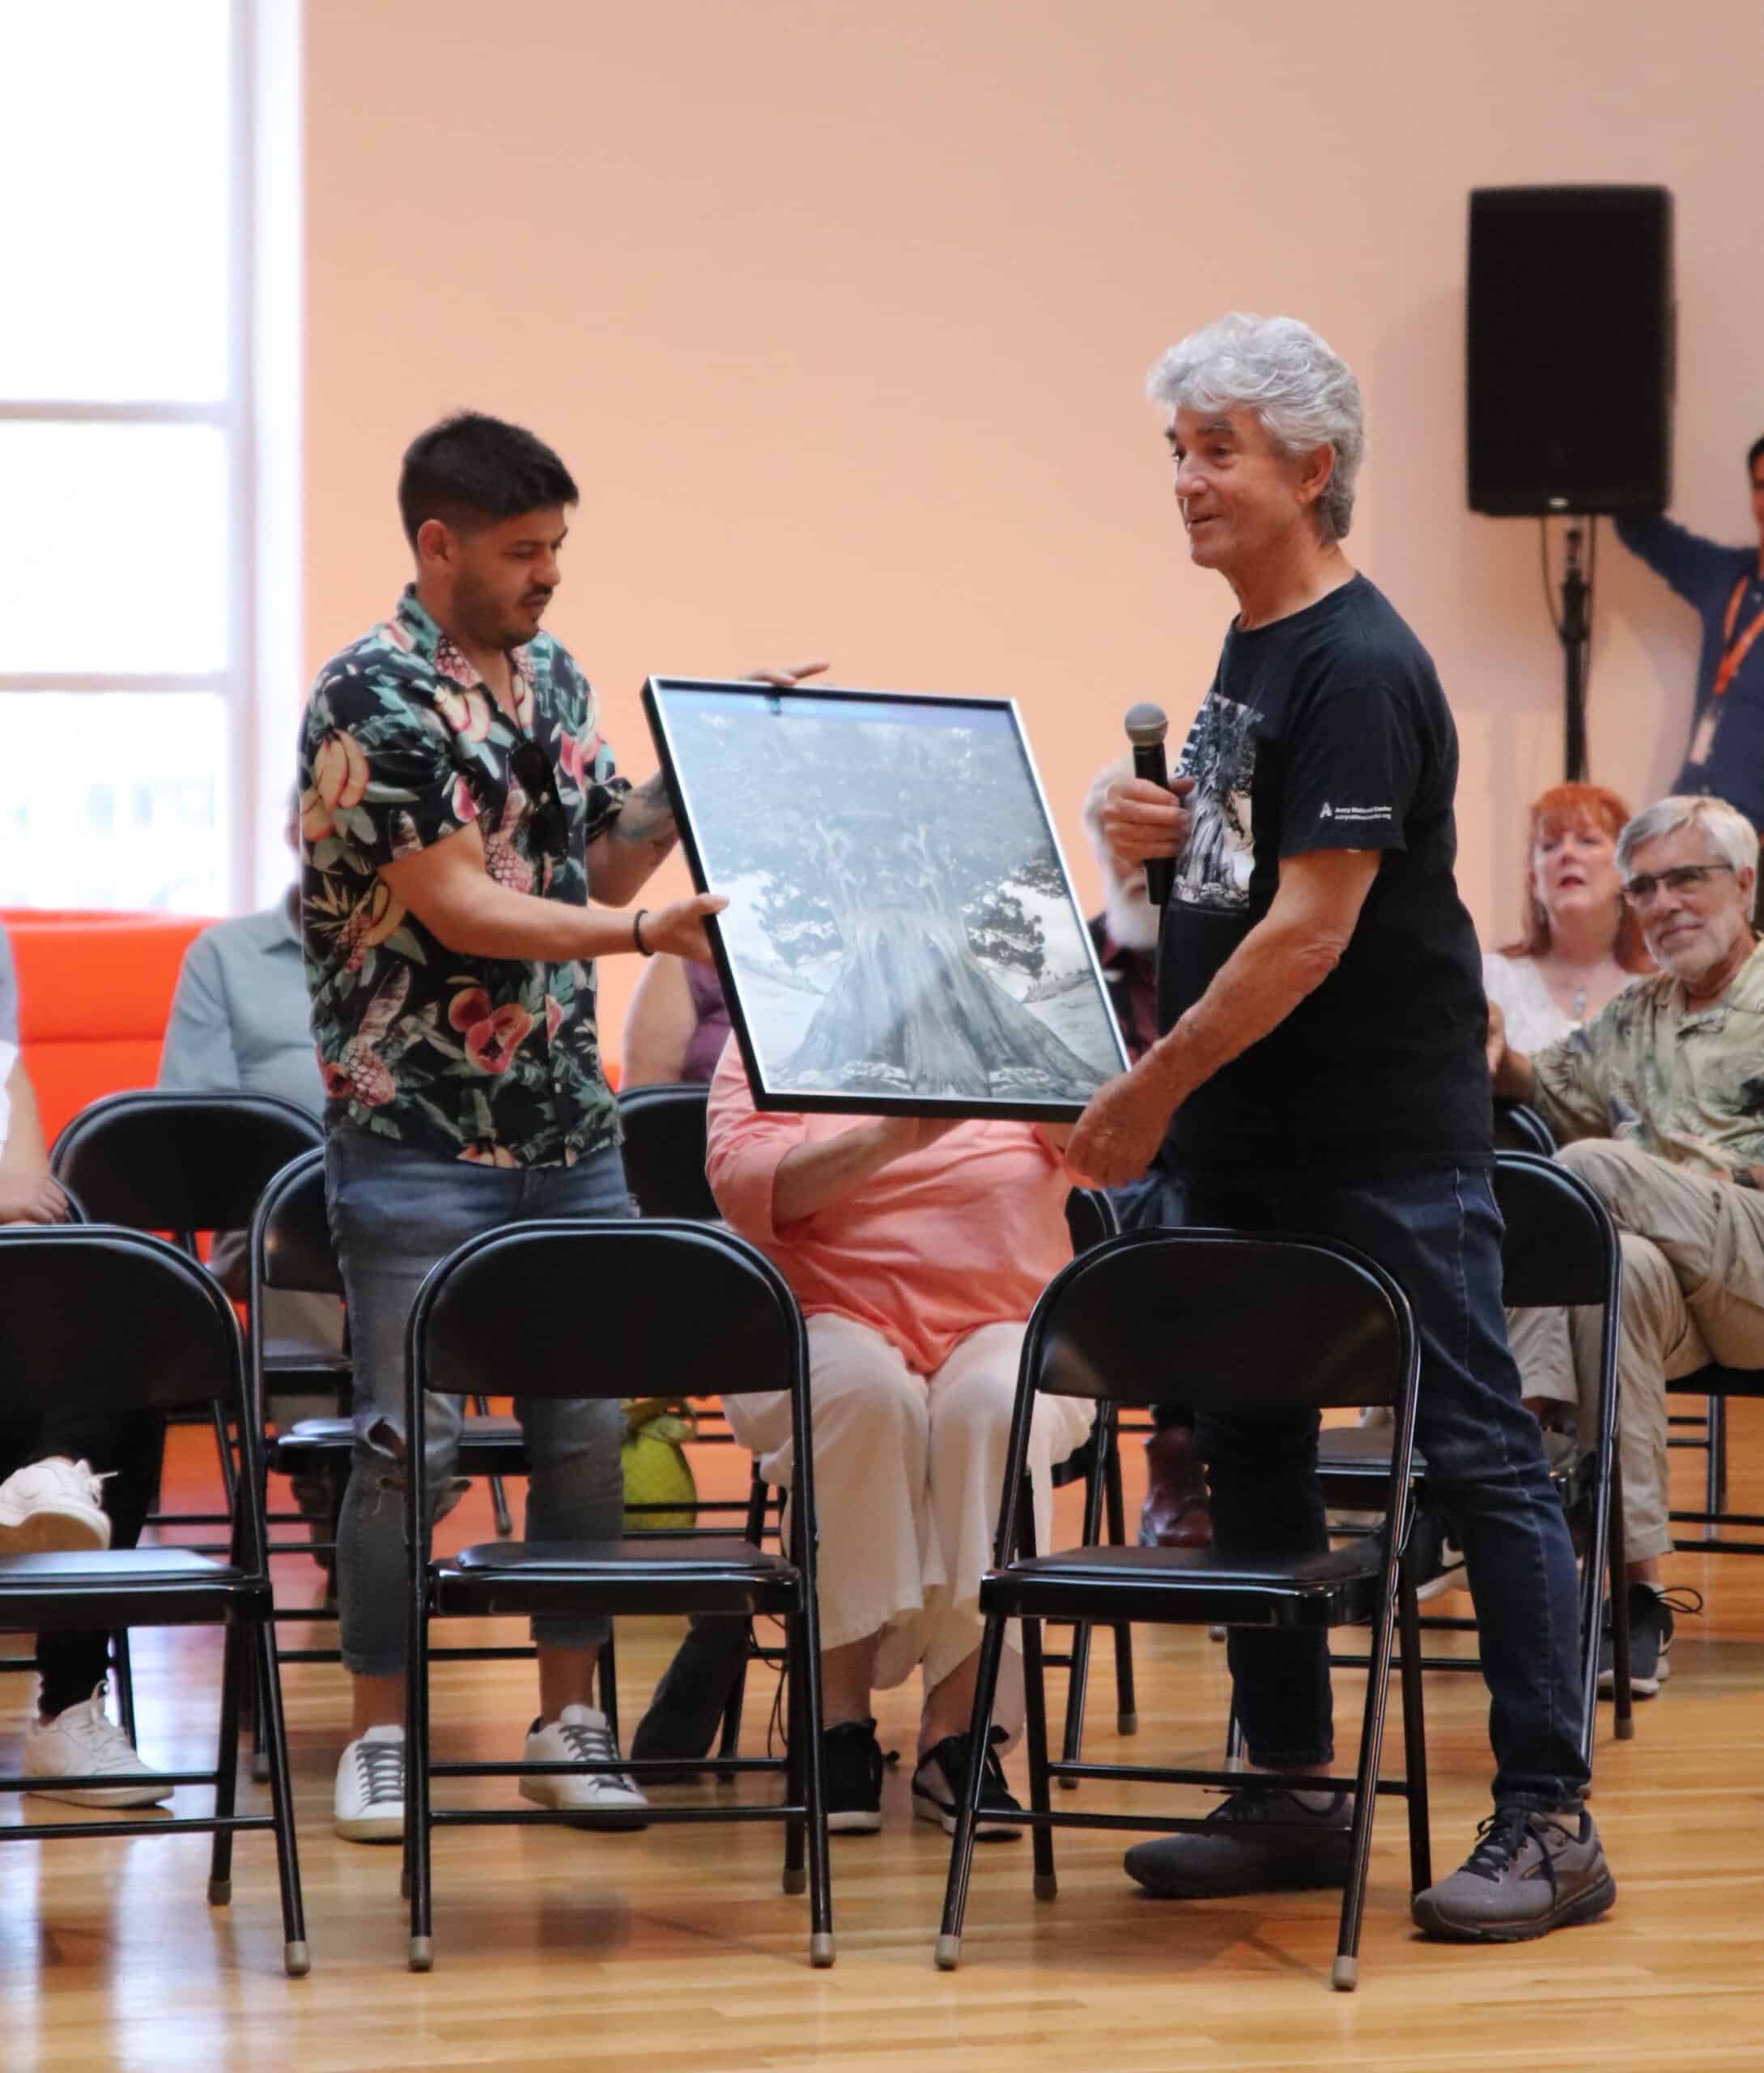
[1465,186,1673,518]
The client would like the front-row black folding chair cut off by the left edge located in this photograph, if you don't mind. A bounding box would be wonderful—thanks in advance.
[0,1225,311,1977]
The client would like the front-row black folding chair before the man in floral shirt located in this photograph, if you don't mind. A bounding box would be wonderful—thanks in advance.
[404,1219,833,1972]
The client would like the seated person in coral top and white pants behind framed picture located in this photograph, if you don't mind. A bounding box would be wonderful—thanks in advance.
[692,1045,1092,1837]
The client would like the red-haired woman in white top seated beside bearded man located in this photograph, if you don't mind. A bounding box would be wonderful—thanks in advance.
[1482,784,1652,1051]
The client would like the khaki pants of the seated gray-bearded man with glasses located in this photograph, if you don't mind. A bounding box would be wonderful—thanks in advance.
[1507,1138,1764,1561]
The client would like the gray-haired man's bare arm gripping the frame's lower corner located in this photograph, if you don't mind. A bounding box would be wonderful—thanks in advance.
[1065,850,1383,1188]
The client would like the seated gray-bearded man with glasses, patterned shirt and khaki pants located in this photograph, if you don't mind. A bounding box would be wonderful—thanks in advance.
[1488,796,1764,1698]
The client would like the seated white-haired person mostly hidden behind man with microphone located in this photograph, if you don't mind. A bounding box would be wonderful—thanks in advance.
[1082,756,1213,1548]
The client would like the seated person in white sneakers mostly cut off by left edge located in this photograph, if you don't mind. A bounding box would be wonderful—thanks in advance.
[0,929,172,1807]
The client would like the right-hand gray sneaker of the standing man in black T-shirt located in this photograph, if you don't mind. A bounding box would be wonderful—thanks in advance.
[1409,1807,1617,1943]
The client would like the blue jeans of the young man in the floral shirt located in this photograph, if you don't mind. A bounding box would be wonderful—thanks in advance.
[325,1130,635,1677]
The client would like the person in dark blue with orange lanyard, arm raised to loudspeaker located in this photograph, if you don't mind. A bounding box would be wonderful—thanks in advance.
[1617,440,1764,827]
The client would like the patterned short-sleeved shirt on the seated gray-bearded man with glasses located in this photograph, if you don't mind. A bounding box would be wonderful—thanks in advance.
[1532,945,1764,1180]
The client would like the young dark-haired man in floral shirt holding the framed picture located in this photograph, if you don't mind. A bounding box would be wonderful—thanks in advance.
[300,415,818,1843]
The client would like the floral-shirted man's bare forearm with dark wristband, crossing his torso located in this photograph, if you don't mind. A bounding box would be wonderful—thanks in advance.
[380,823,728,964]
